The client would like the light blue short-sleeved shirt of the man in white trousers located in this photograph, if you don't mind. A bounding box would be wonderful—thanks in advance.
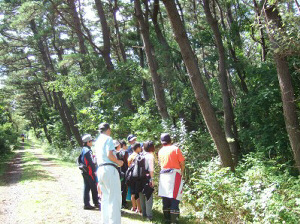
[95,134,117,165]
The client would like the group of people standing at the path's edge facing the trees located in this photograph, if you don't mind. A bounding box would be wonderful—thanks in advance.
[80,123,185,224]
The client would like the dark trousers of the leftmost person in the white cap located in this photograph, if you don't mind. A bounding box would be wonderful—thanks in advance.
[82,174,99,206]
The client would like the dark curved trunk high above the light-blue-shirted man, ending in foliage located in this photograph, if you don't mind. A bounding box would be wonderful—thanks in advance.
[95,0,114,71]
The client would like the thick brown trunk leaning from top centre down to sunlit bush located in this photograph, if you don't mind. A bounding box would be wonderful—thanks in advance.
[163,0,234,170]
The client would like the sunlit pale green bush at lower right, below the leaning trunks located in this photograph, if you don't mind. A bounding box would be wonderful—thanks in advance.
[184,153,300,223]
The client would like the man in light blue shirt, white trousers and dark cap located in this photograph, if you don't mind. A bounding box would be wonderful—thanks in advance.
[95,123,123,224]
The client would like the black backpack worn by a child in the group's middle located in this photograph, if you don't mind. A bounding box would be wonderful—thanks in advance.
[125,154,148,184]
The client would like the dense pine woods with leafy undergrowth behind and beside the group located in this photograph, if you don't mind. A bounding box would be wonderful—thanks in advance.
[0,0,300,223]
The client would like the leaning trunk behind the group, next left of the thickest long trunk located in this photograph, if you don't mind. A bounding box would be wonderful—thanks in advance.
[134,0,169,120]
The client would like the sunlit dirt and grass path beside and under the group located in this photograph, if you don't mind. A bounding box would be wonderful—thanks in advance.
[0,139,195,224]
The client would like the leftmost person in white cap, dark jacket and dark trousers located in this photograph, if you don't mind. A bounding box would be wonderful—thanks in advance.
[80,134,100,209]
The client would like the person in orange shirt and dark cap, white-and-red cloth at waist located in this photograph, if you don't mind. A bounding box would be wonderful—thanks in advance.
[158,133,185,224]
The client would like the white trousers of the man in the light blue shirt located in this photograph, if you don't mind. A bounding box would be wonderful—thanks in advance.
[97,165,122,224]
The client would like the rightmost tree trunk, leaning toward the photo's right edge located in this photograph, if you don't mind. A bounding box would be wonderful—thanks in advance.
[264,5,300,172]
